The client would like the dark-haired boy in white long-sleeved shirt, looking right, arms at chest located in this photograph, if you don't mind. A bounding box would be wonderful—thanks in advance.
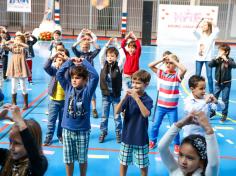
[183,75,224,137]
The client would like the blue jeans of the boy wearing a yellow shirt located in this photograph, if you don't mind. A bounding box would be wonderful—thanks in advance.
[46,100,65,139]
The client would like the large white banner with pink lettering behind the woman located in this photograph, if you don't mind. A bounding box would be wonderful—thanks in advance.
[157,5,218,45]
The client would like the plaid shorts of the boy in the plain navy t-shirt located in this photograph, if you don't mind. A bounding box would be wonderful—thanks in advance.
[119,142,149,169]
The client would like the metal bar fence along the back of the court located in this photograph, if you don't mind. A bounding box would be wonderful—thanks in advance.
[0,0,236,39]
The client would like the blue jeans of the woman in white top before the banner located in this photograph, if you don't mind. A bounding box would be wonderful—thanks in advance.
[196,61,213,93]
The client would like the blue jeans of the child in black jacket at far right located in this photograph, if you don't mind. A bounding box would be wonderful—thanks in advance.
[214,82,231,116]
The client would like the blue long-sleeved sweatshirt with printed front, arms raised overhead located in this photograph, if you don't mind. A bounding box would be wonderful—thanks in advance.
[56,59,99,131]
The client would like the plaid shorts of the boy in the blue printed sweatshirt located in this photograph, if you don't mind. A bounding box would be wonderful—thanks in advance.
[62,129,90,164]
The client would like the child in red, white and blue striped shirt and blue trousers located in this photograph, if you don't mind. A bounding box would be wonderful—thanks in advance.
[149,54,187,153]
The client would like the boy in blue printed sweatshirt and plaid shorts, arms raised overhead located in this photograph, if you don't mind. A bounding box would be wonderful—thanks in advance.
[56,58,99,176]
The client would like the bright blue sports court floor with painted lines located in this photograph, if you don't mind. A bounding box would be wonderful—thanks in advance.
[0,40,236,176]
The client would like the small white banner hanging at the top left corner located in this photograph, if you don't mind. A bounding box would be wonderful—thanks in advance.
[7,0,31,12]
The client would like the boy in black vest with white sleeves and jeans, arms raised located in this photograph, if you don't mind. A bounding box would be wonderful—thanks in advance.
[99,38,125,143]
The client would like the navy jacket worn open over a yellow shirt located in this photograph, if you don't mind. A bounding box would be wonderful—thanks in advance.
[43,59,58,96]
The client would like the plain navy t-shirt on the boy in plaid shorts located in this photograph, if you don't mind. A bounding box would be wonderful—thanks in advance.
[122,93,153,146]
